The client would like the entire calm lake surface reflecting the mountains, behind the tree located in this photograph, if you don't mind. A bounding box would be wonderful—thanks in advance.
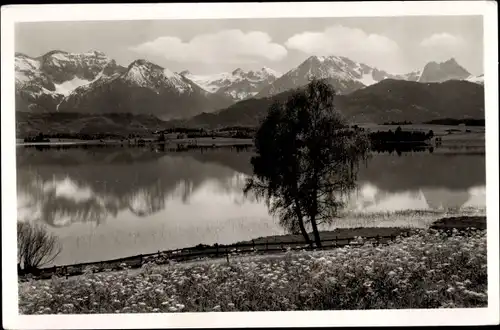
[17,147,486,265]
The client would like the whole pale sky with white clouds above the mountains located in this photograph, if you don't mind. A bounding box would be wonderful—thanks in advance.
[15,16,483,75]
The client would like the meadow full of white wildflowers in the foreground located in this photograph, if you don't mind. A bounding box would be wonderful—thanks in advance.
[19,230,487,314]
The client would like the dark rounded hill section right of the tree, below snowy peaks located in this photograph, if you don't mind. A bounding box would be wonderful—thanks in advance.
[338,79,484,123]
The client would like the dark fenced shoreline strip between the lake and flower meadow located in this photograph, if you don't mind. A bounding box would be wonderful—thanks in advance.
[18,215,486,280]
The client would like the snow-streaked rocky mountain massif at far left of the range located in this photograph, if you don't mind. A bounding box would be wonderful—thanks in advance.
[16,51,232,119]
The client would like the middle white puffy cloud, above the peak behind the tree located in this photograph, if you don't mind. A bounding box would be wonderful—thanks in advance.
[285,25,401,70]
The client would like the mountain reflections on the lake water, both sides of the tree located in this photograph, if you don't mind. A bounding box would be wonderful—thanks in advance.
[17,146,485,227]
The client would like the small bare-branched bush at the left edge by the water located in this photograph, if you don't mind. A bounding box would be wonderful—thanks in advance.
[17,222,61,272]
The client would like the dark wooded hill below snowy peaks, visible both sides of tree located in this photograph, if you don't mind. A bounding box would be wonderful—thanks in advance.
[176,79,484,128]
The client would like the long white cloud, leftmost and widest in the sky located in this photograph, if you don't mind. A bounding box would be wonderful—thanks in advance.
[130,29,288,63]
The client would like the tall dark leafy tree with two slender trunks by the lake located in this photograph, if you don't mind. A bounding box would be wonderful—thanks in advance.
[245,79,370,247]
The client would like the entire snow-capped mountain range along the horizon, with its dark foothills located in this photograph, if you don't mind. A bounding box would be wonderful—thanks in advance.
[15,50,484,129]
